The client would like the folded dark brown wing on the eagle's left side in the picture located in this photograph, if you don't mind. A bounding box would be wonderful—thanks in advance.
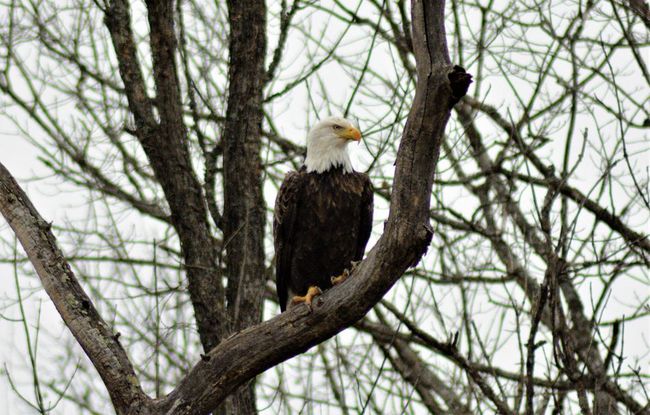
[273,171,303,311]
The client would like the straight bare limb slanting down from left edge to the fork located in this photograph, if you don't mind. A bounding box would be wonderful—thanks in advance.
[0,164,149,414]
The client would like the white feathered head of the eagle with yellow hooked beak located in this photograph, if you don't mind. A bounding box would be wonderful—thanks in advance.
[305,117,361,173]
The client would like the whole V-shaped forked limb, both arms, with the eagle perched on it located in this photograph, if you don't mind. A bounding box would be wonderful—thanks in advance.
[0,0,471,414]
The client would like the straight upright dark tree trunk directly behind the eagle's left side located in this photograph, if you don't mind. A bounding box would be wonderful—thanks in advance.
[223,0,266,414]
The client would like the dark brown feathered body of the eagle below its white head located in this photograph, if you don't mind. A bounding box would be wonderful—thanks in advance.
[273,167,373,311]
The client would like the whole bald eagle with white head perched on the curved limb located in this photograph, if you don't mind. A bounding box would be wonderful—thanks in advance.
[273,117,373,311]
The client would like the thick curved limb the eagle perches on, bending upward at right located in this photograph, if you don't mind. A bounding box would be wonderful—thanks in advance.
[148,1,460,414]
